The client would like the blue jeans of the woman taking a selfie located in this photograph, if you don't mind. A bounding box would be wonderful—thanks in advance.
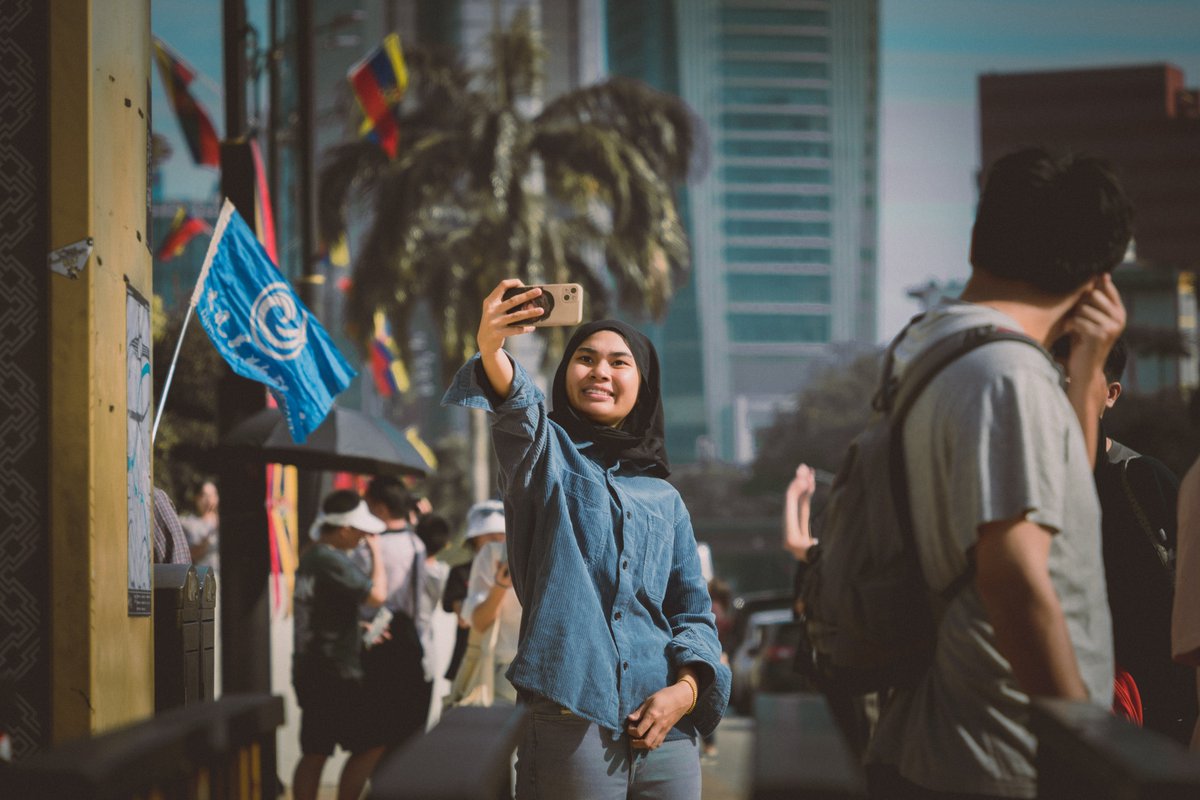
[516,699,700,800]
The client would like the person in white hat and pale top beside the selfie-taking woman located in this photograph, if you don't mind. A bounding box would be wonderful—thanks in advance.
[462,500,521,704]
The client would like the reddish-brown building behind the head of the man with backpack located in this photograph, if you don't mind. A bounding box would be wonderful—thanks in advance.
[979,64,1200,392]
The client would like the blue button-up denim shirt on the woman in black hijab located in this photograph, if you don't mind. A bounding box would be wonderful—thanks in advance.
[442,355,730,738]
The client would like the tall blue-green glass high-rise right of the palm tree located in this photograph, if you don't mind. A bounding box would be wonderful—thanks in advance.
[606,0,878,462]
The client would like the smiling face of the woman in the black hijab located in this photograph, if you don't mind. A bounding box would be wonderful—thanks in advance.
[566,331,642,428]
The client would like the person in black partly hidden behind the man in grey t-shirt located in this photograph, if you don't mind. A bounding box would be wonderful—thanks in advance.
[1054,338,1196,745]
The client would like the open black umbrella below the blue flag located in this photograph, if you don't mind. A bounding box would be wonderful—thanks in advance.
[221,405,431,476]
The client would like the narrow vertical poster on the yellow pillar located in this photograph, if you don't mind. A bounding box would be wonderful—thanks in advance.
[125,287,154,616]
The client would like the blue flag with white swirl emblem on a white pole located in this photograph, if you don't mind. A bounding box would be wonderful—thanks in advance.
[192,200,355,444]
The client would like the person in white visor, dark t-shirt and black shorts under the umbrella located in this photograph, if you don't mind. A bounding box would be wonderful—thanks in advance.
[292,489,388,800]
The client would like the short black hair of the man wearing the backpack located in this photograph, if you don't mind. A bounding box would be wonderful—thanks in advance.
[971,148,1133,295]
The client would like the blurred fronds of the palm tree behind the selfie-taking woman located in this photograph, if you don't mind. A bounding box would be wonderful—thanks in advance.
[318,7,698,381]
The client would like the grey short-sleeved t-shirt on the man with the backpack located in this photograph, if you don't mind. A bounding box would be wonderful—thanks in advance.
[868,302,1112,798]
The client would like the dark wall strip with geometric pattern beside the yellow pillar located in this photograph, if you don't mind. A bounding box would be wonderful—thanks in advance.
[0,0,50,760]
